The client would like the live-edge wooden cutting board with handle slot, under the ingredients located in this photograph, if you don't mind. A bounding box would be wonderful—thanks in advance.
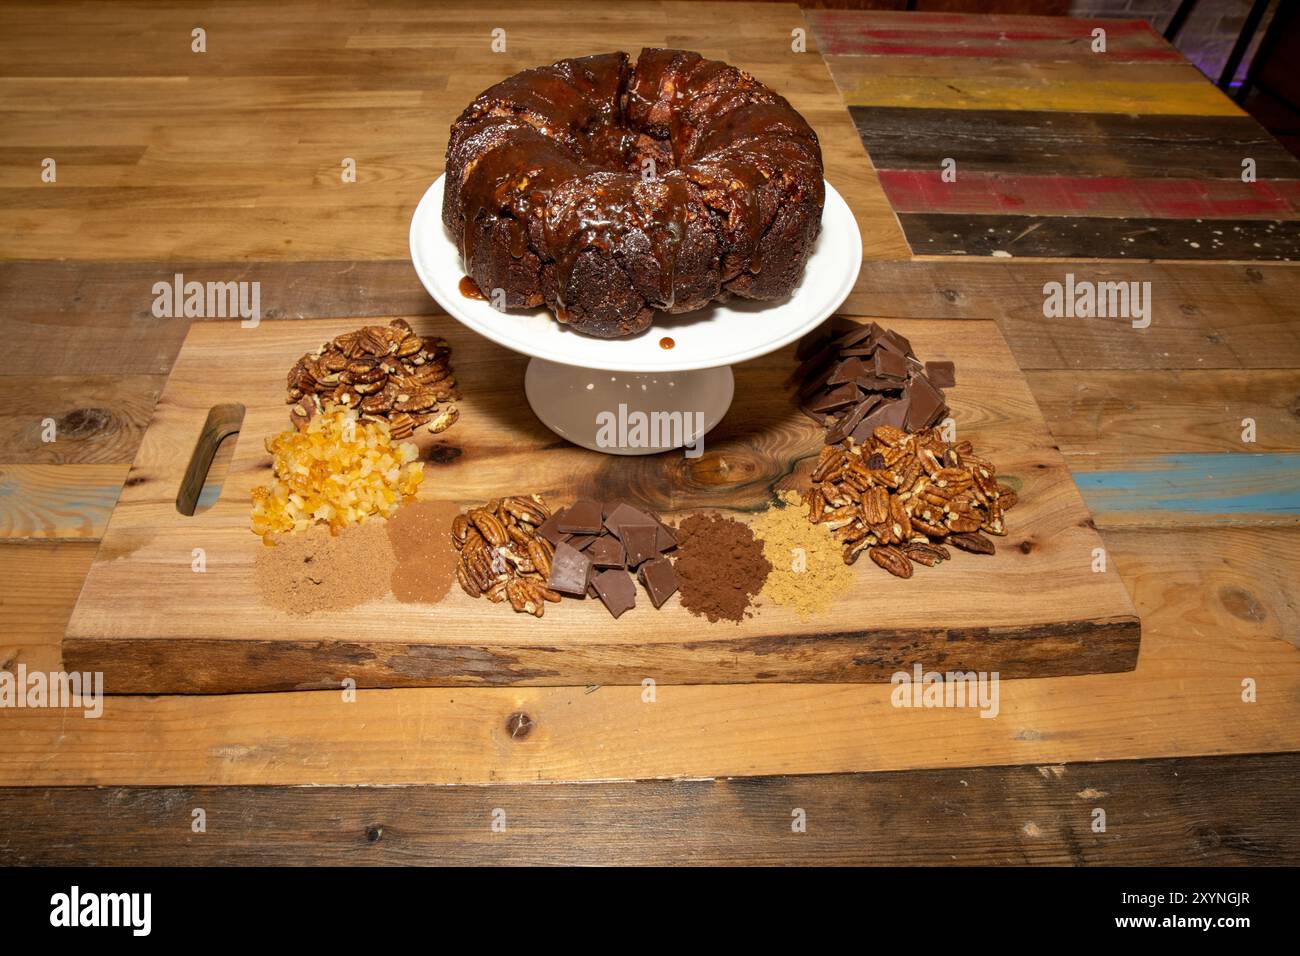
[64,317,1140,693]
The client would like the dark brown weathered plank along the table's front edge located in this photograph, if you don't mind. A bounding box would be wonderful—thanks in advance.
[0,754,1300,866]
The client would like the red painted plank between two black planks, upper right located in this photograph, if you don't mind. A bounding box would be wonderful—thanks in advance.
[878,169,1300,220]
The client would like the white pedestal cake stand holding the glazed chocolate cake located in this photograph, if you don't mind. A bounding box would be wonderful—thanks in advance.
[411,176,862,455]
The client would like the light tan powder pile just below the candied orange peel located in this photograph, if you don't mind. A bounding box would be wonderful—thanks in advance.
[254,518,397,614]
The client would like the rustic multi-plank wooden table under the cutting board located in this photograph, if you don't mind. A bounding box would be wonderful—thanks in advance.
[0,0,1300,864]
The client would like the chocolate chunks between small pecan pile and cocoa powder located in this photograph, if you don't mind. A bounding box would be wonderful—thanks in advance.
[537,498,677,618]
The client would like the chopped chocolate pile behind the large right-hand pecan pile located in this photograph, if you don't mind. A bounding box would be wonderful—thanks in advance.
[785,317,956,445]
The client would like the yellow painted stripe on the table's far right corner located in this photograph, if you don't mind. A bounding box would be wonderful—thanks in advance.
[844,77,1244,116]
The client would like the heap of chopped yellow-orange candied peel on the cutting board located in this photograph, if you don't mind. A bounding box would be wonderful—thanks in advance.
[252,406,424,544]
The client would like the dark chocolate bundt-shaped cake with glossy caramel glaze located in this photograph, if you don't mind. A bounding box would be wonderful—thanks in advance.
[442,49,824,338]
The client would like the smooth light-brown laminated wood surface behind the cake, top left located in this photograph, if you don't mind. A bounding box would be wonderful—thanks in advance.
[0,0,907,261]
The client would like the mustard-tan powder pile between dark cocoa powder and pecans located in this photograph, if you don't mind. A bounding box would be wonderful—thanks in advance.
[753,492,853,619]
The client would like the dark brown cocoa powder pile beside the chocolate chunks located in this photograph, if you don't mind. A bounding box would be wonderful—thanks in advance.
[672,512,772,622]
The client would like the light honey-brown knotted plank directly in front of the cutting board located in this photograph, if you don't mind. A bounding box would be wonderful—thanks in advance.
[0,528,1300,786]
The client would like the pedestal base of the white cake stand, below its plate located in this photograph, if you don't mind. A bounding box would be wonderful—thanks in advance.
[524,359,736,455]
